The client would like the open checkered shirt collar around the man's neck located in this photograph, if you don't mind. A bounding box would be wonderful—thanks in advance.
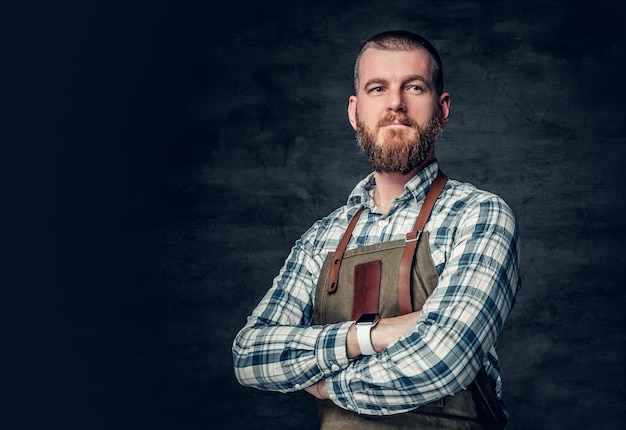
[348,160,439,208]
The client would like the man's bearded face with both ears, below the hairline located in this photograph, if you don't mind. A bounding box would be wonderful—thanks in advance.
[348,49,450,174]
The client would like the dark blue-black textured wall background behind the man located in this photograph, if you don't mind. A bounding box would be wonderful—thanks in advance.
[6,0,626,430]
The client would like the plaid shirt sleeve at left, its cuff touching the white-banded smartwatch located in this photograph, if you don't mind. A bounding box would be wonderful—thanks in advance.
[232,222,352,392]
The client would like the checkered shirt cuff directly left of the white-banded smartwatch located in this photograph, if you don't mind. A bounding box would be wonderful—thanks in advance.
[315,321,354,377]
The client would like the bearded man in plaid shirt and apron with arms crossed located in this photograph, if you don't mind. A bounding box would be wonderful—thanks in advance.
[233,31,520,429]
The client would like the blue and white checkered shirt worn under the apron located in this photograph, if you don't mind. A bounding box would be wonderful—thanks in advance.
[233,162,520,415]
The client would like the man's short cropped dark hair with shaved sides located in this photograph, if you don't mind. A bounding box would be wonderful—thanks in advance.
[354,30,443,96]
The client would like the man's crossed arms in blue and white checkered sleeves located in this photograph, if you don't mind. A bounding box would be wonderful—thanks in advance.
[233,194,519,415]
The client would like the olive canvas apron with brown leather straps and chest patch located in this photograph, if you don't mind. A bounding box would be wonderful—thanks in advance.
[315,173,506,430]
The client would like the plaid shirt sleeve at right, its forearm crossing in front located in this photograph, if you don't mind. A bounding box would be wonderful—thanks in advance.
[326,195,520,415]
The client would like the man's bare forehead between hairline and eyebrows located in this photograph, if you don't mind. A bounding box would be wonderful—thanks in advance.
[358,48,435,85]
